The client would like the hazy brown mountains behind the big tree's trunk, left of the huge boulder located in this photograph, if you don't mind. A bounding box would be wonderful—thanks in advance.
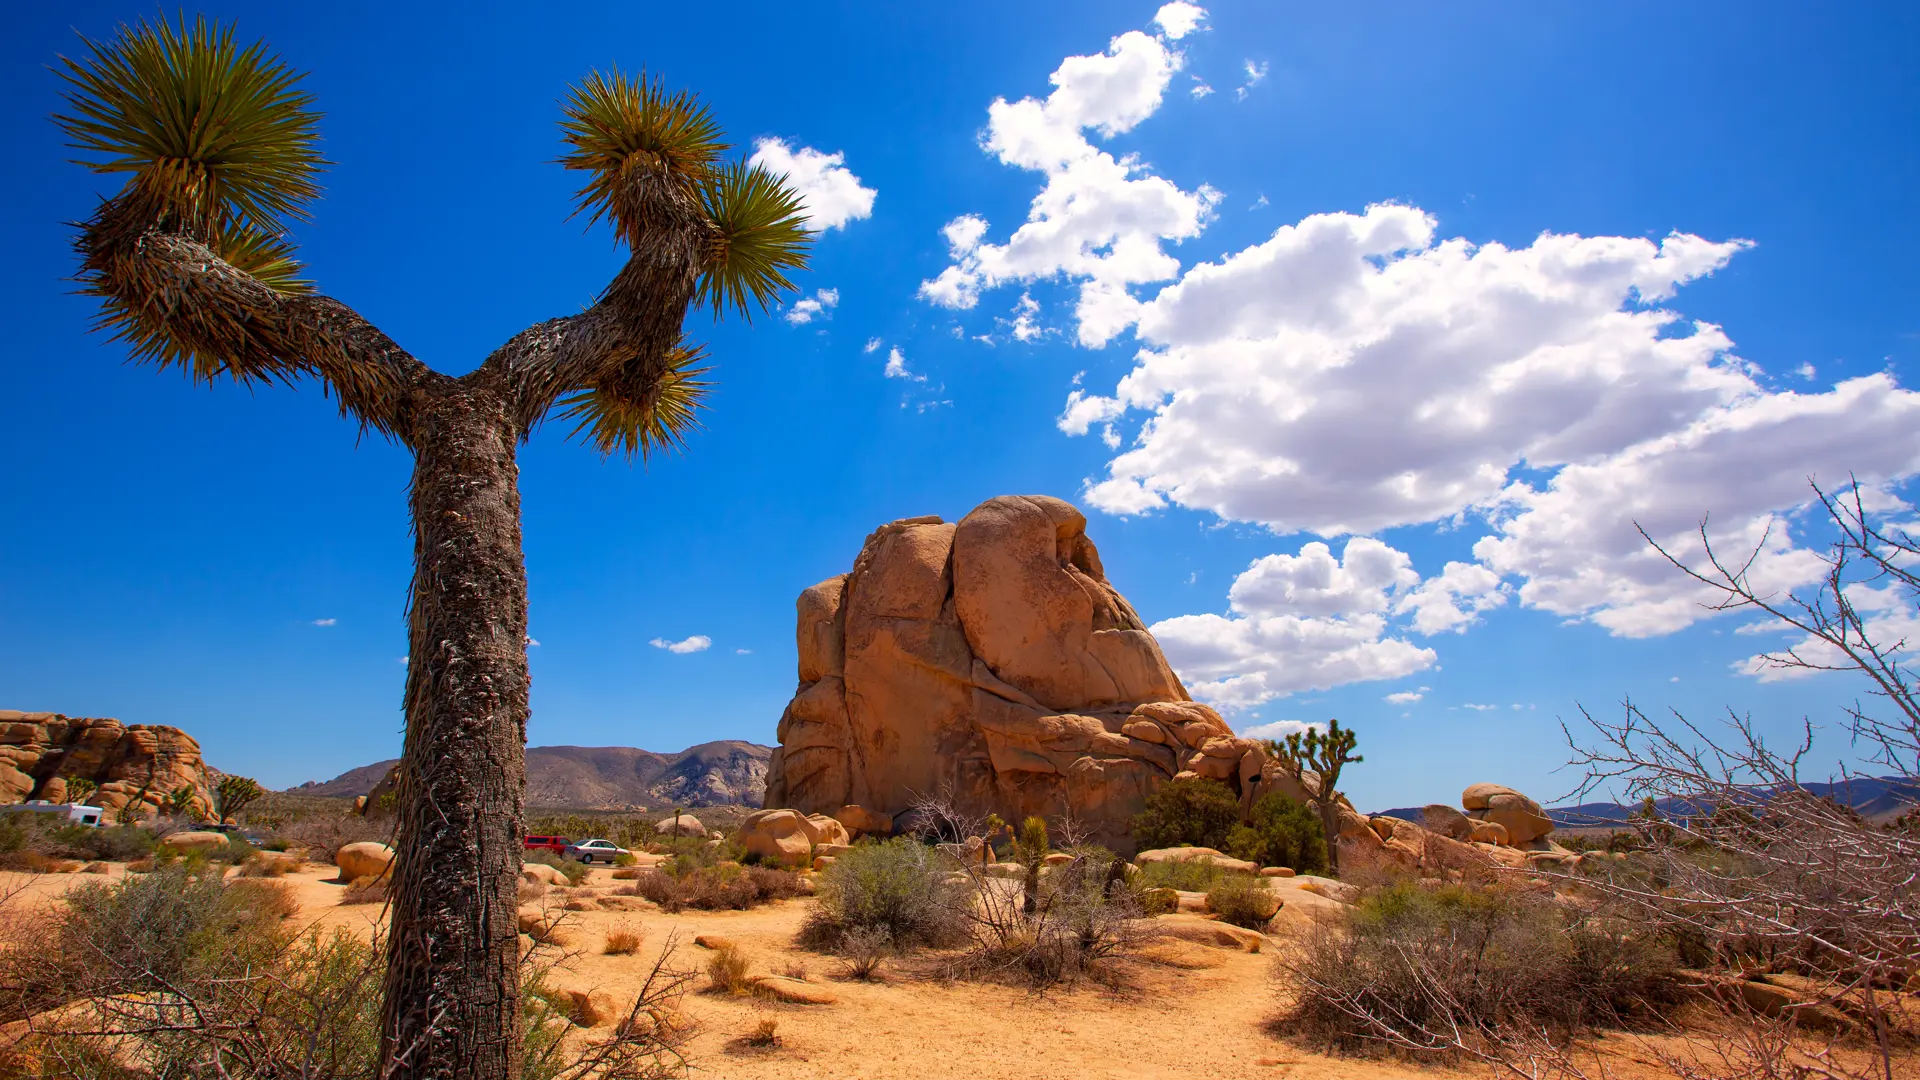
[288,740,774,809]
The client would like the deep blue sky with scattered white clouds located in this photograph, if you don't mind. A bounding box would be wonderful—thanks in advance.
[0,4,1920,807]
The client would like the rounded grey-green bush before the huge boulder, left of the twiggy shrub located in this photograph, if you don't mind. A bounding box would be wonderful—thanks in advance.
[801,838,973,951]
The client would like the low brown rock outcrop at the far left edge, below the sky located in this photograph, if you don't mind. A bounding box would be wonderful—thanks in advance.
[0,709,213,821]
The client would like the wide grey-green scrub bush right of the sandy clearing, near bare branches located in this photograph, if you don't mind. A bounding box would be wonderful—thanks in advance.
[1281,882,1678,1053]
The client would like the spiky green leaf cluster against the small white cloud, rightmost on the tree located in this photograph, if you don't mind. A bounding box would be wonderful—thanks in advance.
[701,163,814,317]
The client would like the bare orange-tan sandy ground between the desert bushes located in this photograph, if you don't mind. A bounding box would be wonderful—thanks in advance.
[0,867,1827,1080]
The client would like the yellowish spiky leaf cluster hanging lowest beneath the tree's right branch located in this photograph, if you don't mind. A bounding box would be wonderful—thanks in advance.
[561,340,712,461]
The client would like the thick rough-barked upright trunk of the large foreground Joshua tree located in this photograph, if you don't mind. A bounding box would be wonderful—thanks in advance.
[380,380,528,1080]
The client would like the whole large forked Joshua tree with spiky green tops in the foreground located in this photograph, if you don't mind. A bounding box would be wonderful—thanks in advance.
[56,15,810,1080]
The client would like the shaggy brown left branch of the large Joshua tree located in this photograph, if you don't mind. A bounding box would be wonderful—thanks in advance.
[75,198,447,440]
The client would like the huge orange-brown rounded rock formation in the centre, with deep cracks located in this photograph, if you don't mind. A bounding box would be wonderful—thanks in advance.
[764,496,1265,851]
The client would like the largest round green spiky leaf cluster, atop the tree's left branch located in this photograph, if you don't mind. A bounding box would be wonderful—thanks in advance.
[54,15,326,290]
